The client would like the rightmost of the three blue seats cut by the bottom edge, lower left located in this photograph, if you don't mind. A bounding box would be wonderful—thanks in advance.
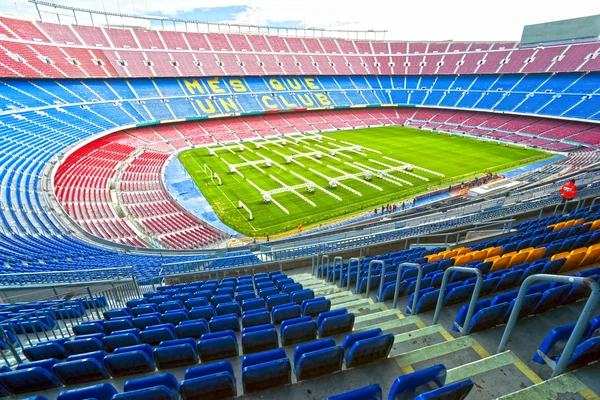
[179,361,237,400]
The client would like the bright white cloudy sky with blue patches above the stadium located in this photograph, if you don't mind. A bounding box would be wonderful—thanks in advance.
[0,0,600,41]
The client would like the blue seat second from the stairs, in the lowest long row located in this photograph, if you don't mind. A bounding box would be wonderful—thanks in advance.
[294,338,344,381]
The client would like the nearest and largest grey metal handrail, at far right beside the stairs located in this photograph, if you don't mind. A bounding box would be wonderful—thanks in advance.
[497,274,600,378]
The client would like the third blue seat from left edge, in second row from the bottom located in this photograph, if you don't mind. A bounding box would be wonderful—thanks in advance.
[104,344,154,377]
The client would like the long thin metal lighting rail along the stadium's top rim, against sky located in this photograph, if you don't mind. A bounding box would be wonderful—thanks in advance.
[27,0,388,40]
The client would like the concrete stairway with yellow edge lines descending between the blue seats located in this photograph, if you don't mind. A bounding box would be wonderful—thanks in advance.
[280,269,600,400]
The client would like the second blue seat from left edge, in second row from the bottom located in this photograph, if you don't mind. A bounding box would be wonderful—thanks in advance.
[52,351,110,385]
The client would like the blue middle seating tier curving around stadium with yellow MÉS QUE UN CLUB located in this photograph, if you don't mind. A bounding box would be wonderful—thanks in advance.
[0,72,600,286]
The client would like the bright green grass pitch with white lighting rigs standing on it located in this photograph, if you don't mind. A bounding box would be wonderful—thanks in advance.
[179,127,548,237]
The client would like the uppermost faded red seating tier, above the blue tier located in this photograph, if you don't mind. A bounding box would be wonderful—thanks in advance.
[0,17,600,78]
